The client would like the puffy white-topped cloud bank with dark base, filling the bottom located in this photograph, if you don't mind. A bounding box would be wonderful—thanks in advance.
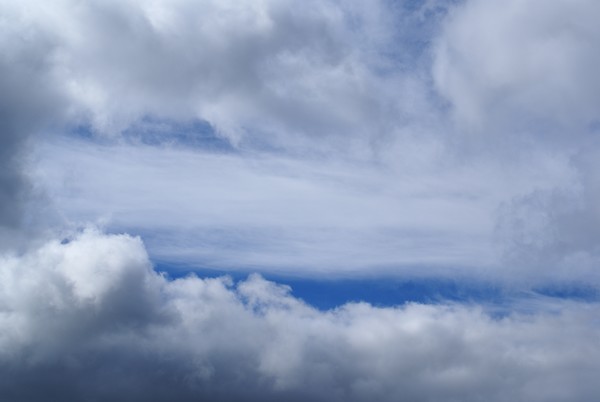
[0,229,600,401]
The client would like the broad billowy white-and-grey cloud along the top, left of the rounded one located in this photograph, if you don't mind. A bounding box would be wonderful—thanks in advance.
[2,0,432,149]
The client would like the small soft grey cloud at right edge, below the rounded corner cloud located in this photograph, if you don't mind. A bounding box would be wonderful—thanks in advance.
[496,141,600,284]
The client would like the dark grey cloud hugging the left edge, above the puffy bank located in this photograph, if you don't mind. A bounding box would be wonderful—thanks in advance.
[0,13,65,242]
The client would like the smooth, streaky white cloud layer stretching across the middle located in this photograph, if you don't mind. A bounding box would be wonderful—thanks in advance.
[35,136,572,278]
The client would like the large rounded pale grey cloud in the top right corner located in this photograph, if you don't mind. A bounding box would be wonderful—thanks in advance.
[433,0,600,137]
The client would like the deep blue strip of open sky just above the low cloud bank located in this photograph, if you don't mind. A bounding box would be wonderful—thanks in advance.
[156,263,600,317]
